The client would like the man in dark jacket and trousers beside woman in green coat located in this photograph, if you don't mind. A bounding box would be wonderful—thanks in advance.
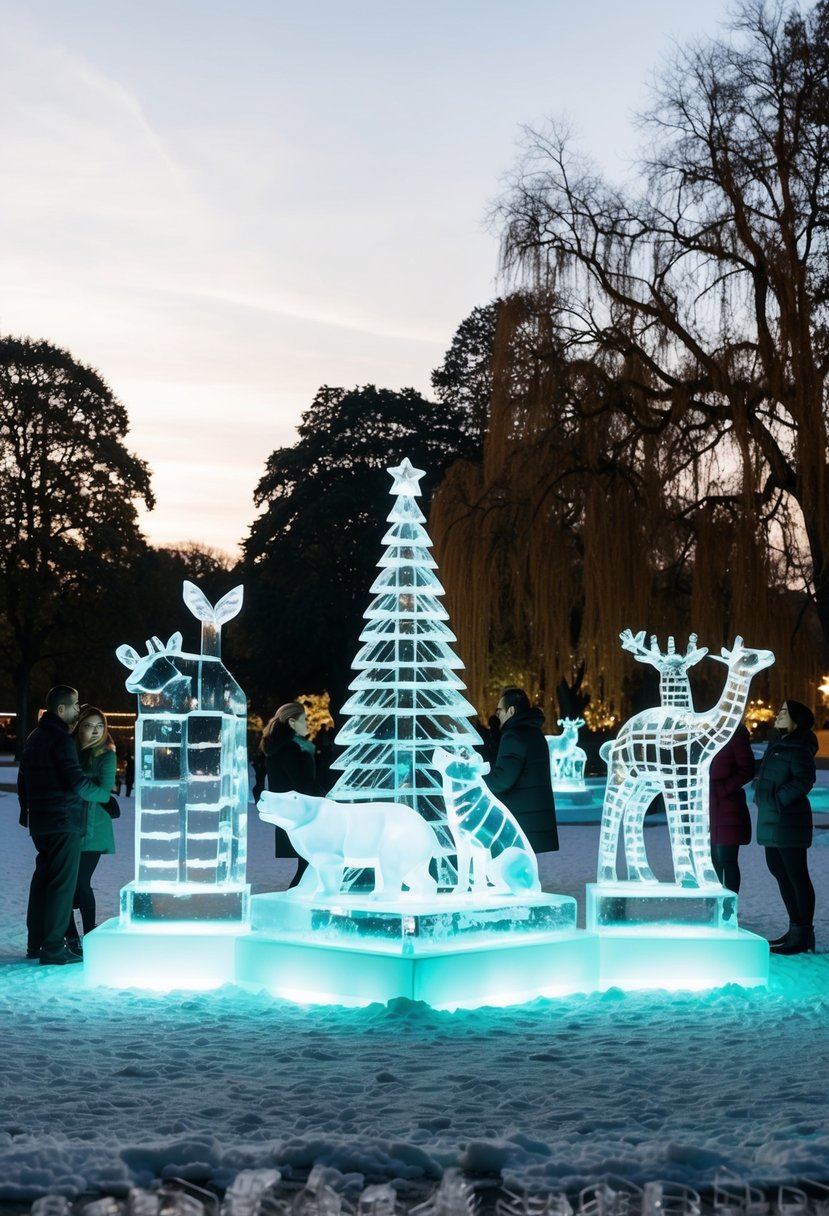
[17,685,106,966]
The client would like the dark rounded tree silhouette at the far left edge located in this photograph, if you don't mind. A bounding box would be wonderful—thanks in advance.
[0,338,153,745]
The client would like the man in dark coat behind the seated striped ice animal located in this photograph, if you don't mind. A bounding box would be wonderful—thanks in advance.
[484,687,558,852]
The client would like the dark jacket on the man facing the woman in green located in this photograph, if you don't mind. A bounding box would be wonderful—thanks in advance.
[17,710,111,835]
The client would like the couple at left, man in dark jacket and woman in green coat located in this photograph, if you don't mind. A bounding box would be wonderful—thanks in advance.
[17,685,115,966]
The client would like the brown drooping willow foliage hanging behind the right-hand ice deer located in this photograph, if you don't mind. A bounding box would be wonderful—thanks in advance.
[430,293,816,725]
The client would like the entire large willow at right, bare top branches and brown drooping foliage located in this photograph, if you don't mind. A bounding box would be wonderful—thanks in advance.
[432,0,829,719]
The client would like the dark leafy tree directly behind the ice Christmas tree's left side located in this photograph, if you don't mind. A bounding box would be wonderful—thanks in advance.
[237,385,480,715]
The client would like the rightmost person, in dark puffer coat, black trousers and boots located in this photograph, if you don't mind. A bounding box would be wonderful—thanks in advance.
[755,698,818,955]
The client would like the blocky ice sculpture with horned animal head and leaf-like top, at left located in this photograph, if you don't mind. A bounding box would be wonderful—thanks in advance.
[117,582,248,918]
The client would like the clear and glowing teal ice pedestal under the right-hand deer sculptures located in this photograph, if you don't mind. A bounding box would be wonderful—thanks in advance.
[586,882,768,990]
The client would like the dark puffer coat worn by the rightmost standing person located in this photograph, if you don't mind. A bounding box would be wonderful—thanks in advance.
[754,728,818,849]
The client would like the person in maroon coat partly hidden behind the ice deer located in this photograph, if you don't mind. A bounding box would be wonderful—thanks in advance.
[709,722,755,894]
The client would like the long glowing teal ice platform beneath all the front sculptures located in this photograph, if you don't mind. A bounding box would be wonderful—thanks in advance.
[84,883,768,1009]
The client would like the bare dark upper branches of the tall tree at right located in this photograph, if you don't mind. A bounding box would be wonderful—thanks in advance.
[497,0,829,666]
